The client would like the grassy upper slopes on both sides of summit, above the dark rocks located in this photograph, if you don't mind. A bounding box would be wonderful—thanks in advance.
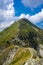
[0,19,43,46]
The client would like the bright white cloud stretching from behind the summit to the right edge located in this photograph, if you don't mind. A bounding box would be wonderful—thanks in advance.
[19,9,43,23]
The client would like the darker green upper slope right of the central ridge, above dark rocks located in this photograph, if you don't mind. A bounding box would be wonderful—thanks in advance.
[19,19,43,44]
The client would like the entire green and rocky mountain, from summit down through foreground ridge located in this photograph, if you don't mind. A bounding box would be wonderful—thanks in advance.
[0,19,43,65]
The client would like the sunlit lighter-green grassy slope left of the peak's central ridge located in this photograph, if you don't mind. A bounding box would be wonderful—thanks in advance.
[0,22,19,46]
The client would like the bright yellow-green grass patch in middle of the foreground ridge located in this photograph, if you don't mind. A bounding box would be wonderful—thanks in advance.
[10,48,31,65]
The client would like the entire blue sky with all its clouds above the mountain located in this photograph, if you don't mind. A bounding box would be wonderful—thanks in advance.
[0,0,43,31]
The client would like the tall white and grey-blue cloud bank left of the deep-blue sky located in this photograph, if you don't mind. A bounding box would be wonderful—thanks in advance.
[0,0,15,31]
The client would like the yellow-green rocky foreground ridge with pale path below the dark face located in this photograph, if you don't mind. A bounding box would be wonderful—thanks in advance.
[0,45,43,65]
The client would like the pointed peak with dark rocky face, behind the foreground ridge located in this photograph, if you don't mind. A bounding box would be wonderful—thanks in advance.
[0,19,43,50]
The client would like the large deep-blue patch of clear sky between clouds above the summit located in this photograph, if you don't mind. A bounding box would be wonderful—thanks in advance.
[14,0,43,16]
